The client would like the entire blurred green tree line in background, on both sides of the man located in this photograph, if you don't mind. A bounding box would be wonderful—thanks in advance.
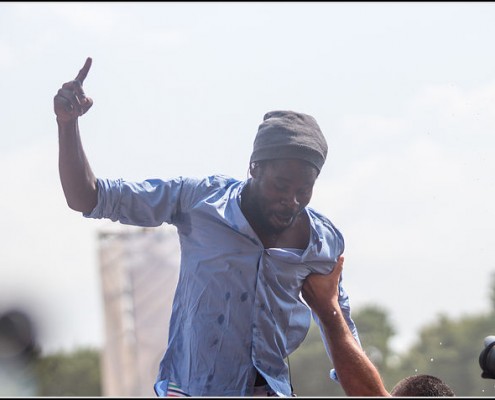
[26,274,495,397]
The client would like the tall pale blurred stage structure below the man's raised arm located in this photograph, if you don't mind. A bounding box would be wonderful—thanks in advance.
[98,225,180,397]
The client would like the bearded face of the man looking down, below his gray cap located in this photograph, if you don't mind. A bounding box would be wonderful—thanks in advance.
[251,159,318,233]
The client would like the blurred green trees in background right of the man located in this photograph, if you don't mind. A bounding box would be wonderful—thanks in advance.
[290,296,495,397]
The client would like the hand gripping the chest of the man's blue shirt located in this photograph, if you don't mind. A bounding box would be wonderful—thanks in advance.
[302,256,344,318]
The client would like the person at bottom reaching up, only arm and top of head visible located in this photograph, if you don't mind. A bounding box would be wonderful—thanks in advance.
[302,256,455,397]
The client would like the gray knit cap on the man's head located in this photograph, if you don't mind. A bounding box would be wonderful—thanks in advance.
[250,111,328,171]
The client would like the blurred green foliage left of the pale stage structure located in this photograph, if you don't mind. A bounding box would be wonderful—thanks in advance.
[36,349,102,396]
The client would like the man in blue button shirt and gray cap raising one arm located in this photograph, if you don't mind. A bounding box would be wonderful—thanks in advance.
[54,58,359,396]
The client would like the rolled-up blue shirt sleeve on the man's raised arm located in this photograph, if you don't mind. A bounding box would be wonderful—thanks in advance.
[83,178,183,227]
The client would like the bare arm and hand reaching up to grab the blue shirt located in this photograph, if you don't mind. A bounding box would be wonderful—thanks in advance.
[302,256,390,397]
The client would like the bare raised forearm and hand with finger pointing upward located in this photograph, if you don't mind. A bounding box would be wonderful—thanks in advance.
[53,57,97,213]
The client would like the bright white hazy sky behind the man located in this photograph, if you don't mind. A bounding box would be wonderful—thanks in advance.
[0,2,495,351]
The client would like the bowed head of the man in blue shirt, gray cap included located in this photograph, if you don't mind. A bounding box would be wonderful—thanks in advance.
[249,111,328,233]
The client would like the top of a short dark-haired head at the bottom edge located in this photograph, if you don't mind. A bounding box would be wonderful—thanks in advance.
[390,374,455,397]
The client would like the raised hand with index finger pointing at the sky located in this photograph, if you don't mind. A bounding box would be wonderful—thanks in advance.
[53,57,93,122]
